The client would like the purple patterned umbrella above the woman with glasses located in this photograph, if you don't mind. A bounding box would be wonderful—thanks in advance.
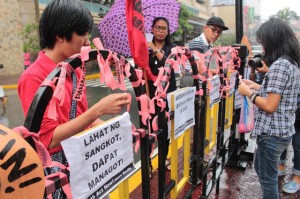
[98,0,180,57]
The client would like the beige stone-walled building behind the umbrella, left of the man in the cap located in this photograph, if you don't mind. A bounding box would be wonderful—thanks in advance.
[0,0,212,78]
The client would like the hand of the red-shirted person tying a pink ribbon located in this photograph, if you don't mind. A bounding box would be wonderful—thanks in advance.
[94,93,130,116]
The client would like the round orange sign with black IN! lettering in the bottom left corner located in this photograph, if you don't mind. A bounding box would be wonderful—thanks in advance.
[0,125,45,199]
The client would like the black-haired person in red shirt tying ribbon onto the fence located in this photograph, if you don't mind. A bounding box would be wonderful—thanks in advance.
[18,0,130,198]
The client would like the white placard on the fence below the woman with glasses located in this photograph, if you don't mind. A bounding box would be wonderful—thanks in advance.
[167,87,196,139]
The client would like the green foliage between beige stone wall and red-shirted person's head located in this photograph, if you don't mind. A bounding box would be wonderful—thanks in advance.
[21,23,40,54]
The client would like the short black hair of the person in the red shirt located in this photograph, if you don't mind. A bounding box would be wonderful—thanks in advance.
[39,0,93,49]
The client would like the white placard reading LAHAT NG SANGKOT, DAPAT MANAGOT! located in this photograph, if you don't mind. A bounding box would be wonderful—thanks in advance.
[61,112,135,199]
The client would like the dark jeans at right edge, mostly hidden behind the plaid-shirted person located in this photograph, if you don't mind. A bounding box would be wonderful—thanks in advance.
[280,121,300,176]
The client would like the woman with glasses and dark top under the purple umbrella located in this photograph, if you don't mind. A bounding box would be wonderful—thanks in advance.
[148,17,176,172]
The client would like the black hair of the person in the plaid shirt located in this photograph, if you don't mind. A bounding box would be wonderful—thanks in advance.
[256,18,300,67]
